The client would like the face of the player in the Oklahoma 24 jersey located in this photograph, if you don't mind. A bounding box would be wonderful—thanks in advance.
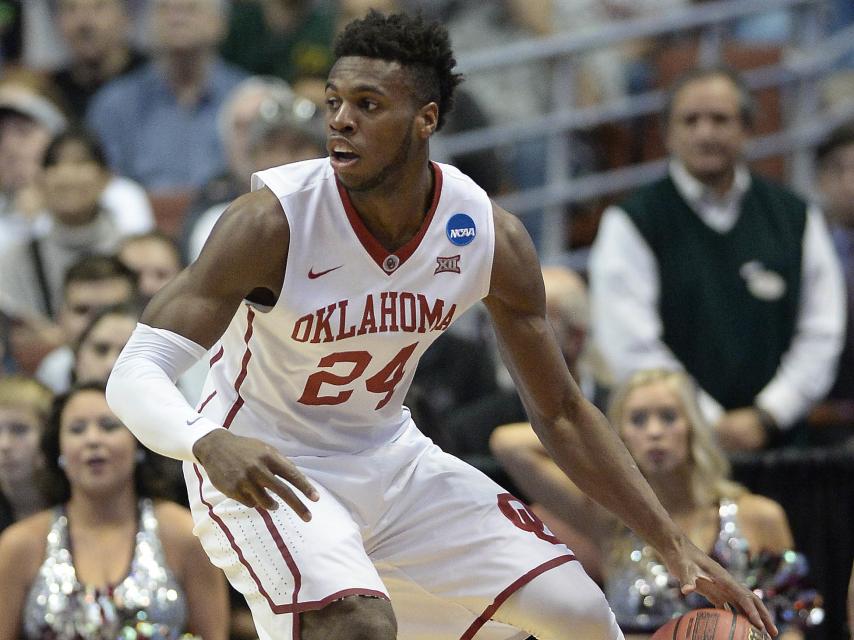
[326,56,423,191]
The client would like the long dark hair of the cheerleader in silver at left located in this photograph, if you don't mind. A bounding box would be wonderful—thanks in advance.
[39,382,175,505]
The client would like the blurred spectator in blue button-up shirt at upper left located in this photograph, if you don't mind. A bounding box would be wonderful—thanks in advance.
[86,0,244,194]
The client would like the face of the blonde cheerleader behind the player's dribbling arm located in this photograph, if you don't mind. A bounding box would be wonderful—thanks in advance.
[620,380,689,477]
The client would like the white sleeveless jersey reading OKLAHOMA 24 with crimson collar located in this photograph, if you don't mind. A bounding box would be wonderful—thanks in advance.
[202,158,494,456]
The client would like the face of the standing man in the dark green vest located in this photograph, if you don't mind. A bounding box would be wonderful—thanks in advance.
[667,76,747,185]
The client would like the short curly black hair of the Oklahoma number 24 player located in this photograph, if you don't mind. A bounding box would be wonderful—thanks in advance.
[334,9,462,131]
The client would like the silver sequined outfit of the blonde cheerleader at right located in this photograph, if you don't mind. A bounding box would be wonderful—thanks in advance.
[605,500,749,632]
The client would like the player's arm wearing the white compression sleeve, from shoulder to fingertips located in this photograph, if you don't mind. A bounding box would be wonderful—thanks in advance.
[107,189,316,519]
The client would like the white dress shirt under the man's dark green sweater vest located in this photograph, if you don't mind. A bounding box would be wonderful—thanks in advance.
[590,161,846,428]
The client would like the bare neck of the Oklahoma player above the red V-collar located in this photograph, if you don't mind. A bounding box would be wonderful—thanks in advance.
[348,161,435,251]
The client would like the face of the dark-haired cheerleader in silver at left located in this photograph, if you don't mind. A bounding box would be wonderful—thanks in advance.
[59,390,137,493]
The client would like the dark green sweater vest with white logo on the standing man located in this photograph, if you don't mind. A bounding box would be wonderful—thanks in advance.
[621,175,807,409]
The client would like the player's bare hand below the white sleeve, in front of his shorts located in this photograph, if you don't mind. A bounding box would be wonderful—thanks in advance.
[193,429,319,522]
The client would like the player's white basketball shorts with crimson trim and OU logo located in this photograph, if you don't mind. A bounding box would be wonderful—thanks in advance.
[184,424,589,640]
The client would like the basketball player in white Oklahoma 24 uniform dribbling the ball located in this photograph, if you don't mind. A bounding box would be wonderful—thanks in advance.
[109,13,776,640]
